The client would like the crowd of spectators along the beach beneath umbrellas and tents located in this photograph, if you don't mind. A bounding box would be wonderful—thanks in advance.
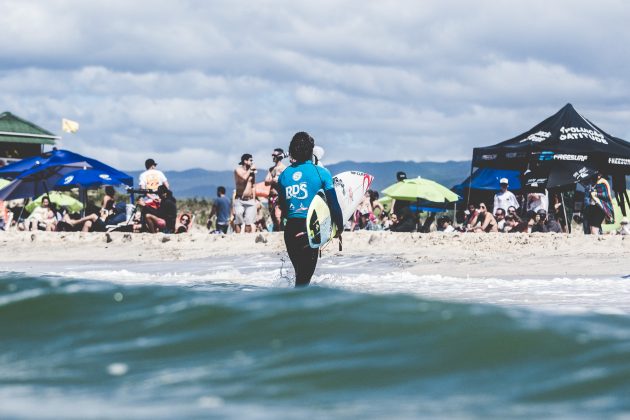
[0,158,630,234]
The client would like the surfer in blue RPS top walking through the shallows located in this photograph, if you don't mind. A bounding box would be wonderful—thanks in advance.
[278,132,343,287]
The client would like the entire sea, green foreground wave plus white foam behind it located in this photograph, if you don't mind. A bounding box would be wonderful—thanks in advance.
[0,256,630,419]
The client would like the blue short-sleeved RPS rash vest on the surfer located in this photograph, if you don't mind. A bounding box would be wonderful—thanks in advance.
[278,161,341,219]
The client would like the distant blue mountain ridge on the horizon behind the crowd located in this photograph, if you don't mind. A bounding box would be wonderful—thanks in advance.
[127,161,470,198]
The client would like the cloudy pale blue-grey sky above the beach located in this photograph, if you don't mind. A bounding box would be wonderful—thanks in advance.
[0,0,630,170]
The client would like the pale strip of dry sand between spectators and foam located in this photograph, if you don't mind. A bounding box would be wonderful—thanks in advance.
[0,231,630,278]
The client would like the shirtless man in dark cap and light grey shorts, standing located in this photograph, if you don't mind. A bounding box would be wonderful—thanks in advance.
[234,153,258,233]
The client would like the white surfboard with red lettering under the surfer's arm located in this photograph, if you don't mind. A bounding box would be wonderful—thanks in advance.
[306,171,374,248]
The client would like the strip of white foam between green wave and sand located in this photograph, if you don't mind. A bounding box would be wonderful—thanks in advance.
[0,255,630,314]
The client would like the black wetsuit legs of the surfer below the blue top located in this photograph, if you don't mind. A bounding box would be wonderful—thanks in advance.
[284,219,319,287]
